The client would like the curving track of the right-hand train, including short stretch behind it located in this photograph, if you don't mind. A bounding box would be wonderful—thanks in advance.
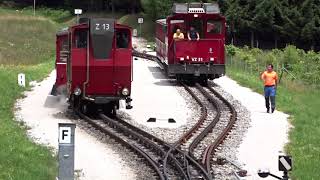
[133,50,237,178]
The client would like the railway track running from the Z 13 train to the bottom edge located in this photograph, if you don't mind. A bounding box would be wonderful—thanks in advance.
[78,113,211,180]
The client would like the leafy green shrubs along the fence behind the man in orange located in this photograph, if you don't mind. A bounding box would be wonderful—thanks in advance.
[226,45,320,84]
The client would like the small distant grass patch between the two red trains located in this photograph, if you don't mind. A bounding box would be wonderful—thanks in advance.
[118,14,156,42]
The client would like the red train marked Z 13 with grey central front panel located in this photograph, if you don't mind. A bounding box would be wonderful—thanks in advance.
[52,18,132,113]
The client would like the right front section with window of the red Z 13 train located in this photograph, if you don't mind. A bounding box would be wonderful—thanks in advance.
[114,28,132,90]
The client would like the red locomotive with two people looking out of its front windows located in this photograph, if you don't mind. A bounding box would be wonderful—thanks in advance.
[156,3,226,84]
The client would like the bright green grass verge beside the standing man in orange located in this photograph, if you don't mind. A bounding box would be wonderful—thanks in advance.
[227,66,320,179]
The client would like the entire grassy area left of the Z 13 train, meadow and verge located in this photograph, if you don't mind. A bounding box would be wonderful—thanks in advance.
[0,7,60,180]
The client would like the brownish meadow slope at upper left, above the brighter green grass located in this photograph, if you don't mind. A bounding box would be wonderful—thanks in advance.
[0,10,59,65]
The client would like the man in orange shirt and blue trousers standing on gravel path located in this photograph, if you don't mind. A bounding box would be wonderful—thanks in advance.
[261,64,278,113]
